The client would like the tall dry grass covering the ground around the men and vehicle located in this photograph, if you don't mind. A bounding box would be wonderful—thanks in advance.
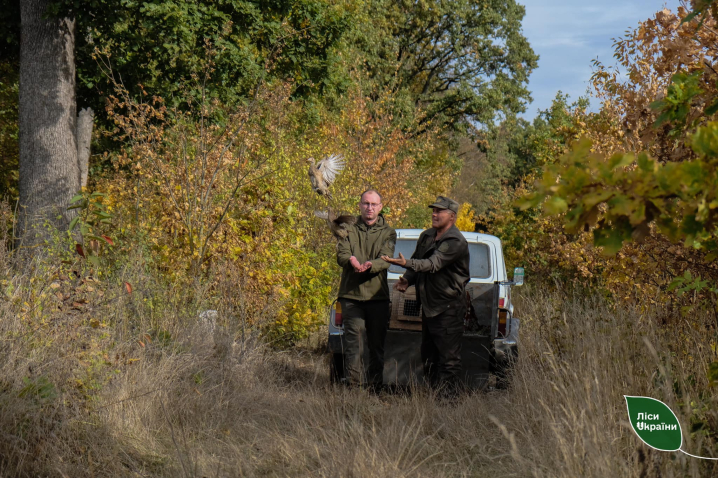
[0,239,718,477]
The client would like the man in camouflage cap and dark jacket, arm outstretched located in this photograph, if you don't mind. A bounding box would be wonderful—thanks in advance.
[384,196,471,393]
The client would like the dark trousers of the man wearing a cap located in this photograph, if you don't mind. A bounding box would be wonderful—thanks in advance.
[421,307,465,389]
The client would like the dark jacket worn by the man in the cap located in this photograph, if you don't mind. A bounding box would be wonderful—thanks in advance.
[404,226,471,317]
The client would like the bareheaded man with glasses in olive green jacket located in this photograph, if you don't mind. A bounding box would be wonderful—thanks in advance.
[337,189,396,390]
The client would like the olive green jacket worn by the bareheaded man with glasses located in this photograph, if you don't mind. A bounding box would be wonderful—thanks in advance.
[337,216,396,300]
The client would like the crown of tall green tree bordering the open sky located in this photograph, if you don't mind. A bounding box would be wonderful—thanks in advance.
[349,0,538,131]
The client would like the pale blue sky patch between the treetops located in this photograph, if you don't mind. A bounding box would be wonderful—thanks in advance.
[518,0,680,120]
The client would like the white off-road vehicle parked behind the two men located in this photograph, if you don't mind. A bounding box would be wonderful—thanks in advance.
[328,229,524,388]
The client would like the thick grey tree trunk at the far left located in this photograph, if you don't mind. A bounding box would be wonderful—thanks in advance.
[17,0,81,246]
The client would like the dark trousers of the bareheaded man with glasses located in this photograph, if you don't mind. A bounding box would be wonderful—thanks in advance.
[339,299,391,386]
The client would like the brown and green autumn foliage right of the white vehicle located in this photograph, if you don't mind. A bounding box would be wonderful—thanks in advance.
[456,8,718,322]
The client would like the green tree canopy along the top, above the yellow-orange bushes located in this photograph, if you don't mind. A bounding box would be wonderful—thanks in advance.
[0,0,538,133]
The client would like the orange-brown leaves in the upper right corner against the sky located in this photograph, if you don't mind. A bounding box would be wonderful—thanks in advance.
[589,7,718,161]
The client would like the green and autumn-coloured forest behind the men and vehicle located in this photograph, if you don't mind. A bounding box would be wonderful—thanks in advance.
[0,0,718,476]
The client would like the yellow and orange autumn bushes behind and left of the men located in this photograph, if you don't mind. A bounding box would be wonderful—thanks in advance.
[83,63,452,344]
